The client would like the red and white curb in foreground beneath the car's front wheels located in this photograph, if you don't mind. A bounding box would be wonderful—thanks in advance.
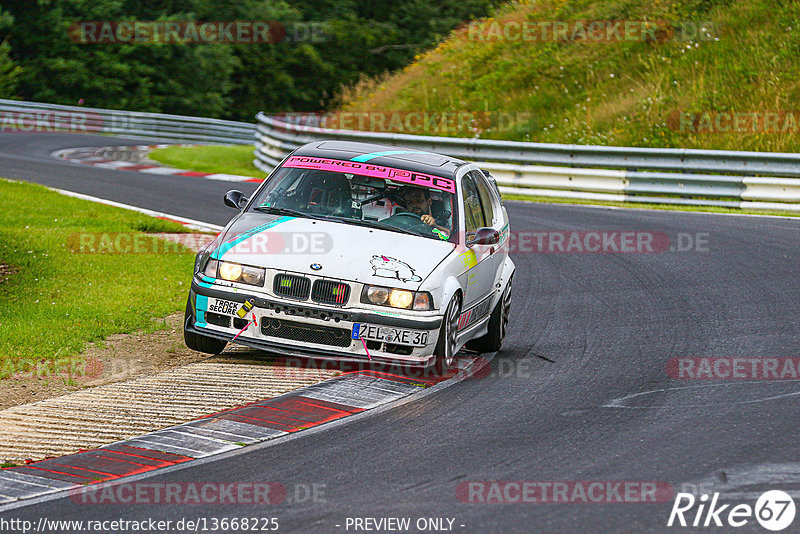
[0,357,490,510]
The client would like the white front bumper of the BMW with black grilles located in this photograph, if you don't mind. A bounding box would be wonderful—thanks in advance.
[191,278,442,365]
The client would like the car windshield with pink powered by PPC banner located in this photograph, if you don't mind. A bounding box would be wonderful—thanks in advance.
[250,156,456,241]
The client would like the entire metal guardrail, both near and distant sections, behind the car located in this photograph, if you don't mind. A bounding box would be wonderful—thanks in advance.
[6,99,800,211]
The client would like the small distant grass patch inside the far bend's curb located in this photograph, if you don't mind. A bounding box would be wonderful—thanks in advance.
[148,145,266,178]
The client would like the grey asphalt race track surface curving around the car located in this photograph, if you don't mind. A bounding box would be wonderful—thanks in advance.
[0,134,800,533]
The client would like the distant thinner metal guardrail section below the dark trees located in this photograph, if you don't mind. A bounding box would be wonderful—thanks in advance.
[0,99,255,145]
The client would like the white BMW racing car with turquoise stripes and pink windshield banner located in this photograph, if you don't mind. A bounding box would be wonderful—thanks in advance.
[184,141,514,373]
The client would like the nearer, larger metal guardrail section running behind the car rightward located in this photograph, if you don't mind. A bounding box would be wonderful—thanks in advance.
[253,113,800,211]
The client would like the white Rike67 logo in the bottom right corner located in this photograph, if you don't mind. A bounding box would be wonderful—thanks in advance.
[667,490,795,532]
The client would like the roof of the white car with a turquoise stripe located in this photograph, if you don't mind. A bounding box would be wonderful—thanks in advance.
[293,141,467,178]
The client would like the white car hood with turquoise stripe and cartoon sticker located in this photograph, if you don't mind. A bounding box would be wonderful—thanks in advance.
[212,213,455,289]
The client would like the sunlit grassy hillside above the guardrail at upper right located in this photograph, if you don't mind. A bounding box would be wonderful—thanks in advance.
[342,0,800,152]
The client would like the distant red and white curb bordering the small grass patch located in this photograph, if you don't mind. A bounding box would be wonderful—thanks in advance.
[52,145,264,183]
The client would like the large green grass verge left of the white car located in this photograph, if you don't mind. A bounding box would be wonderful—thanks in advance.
[0,179,194,378]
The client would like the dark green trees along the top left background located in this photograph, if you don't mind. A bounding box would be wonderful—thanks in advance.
[0,0,499,121]
